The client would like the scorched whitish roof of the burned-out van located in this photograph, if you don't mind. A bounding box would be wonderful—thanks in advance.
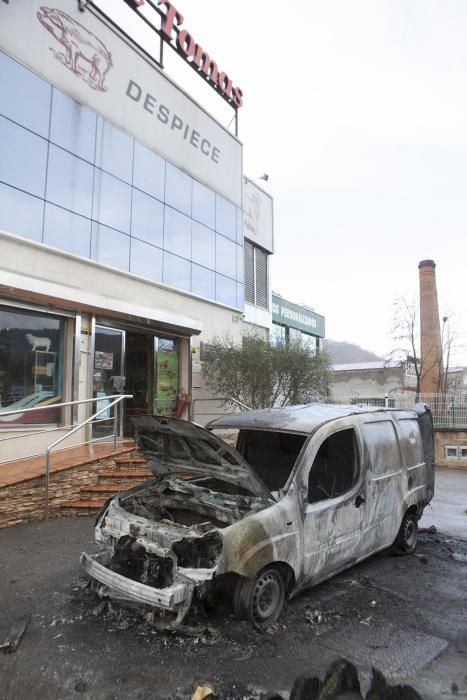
[206,403,417,435]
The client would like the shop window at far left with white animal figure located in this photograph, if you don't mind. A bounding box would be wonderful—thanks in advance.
[0,307,65,427]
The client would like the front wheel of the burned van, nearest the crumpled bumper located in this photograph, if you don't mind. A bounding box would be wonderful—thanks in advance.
[234,567,285,629]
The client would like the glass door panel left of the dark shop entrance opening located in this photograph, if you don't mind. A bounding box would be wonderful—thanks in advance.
[92,326,125,438]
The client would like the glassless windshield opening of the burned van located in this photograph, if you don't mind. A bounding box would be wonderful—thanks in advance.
[237,430,307,491]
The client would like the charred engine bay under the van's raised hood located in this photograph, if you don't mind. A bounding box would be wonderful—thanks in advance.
[119,478,270,530]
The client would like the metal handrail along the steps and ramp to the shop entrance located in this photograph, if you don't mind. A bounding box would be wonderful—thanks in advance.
[0,394,133,520]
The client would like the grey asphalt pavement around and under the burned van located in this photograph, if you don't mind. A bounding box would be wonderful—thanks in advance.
[0,462,467,700]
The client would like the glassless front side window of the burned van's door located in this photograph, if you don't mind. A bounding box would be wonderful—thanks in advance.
[308,429,360,503]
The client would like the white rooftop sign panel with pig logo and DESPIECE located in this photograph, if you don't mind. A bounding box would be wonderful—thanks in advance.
[0,0,242,207]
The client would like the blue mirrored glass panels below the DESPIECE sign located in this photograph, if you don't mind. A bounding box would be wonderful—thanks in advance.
[0,52,247,309]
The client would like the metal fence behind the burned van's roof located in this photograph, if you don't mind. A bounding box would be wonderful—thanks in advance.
[326,392,467,430]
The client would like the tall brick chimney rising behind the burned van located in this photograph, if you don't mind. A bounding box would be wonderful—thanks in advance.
[418,260,443,394]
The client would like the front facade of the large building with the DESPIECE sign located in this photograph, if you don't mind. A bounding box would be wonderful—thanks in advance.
[0,0,244,458]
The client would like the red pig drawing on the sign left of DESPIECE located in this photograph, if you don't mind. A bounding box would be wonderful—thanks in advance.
[37,7,112,92]
